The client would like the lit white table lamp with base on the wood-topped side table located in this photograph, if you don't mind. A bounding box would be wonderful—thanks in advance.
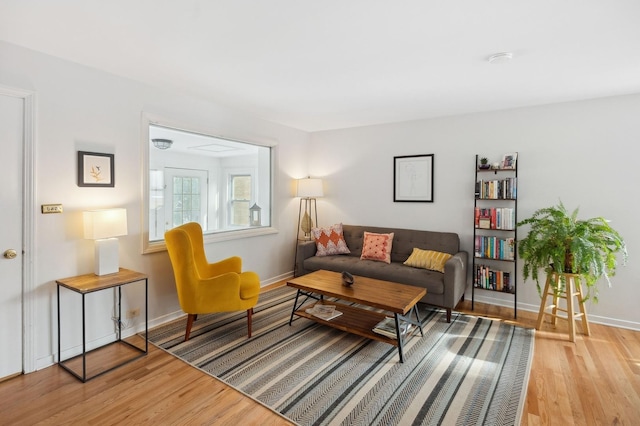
[83,208,127,275]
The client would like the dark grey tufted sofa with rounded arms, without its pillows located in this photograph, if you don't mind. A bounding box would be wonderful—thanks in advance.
[295,225,468,322]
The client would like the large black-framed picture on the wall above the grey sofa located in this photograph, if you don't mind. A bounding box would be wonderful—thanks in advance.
[393,154,434,203]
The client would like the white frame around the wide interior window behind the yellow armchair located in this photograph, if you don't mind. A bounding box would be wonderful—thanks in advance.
[140,112,278,254]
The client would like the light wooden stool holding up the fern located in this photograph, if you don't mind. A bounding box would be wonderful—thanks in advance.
[536,271,591,342]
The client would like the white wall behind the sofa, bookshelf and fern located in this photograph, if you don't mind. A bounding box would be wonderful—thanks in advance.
[309,95,640,329]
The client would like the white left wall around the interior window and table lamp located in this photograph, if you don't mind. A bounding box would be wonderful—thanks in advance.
[0,42,309,368]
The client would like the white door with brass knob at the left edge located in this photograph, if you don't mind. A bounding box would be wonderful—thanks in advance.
[0,94,24,380]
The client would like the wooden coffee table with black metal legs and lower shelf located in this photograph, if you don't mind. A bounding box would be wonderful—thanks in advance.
[287,270,427,362]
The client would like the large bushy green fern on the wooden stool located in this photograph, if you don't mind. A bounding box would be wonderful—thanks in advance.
[518,202,628,302]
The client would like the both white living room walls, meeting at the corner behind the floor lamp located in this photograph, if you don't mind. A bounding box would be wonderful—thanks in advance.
[0,42,640,368]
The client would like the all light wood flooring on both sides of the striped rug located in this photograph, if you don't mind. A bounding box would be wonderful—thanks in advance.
[0,284,640,425]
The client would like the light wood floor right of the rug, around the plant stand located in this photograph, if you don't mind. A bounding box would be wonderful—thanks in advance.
[458,301,640,425]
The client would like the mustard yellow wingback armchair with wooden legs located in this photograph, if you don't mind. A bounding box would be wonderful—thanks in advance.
[164,222,260,341]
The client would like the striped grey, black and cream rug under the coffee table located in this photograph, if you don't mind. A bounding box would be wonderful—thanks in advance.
[149,287,534,425]
